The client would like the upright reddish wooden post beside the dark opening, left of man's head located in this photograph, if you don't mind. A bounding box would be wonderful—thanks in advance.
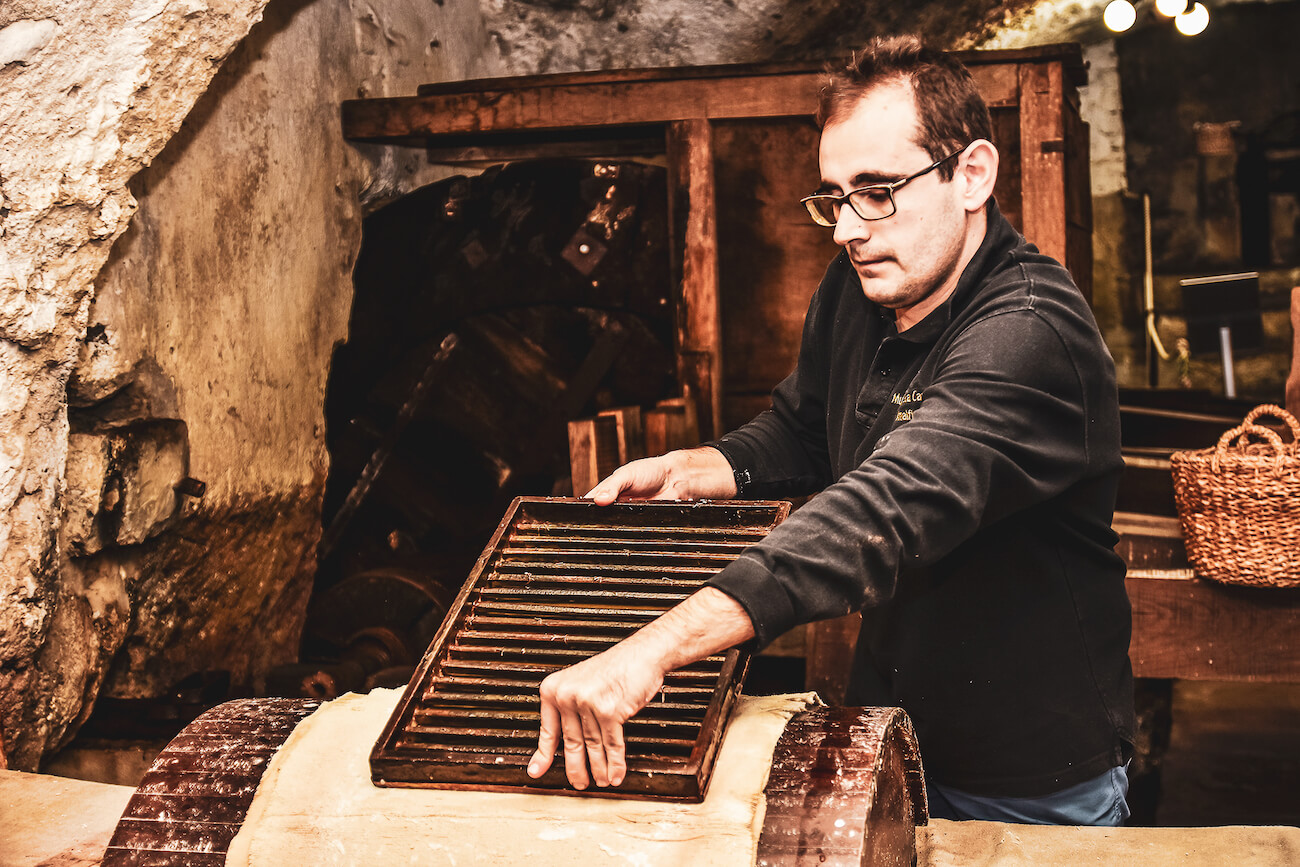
[667,117,725,439]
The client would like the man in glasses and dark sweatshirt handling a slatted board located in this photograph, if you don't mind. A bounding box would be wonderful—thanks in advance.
[529,38,1134,824]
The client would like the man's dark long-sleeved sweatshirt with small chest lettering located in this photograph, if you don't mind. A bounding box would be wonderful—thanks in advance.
[711,201,1135,797]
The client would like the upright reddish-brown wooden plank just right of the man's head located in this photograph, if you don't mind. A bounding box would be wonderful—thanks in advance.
[1019,64,1069,271]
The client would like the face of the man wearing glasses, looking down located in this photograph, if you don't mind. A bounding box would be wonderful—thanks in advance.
[819,83,967,328]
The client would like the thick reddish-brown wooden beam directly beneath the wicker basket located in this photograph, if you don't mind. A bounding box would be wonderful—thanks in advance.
[1126,572,1300,682]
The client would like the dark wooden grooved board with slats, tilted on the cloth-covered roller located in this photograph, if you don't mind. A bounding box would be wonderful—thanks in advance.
[371,499,789,799]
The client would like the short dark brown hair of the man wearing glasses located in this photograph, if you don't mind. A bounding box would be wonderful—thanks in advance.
[816,35,993,181]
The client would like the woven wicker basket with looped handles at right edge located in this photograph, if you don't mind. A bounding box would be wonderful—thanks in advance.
[1170,404,1300,588]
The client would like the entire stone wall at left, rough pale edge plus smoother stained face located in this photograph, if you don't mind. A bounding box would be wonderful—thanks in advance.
[0,0,497,768]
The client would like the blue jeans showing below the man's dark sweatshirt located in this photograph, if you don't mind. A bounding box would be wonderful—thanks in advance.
[926,767,1128,825]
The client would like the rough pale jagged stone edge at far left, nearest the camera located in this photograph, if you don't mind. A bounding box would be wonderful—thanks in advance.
[0,0,264,767]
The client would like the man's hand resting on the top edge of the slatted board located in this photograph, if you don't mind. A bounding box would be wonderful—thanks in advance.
[586,446,736,506]
